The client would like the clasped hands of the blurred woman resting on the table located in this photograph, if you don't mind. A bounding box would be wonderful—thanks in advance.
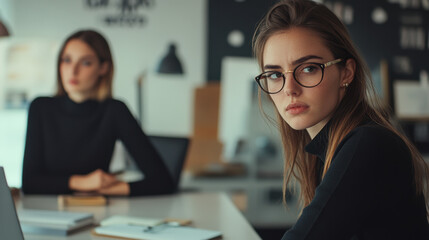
[69,169,119,192]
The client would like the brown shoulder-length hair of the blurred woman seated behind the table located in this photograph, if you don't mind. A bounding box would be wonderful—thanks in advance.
[55,30,114,101]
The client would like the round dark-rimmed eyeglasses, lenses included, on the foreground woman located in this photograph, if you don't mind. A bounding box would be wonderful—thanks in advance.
[255,58,343,94]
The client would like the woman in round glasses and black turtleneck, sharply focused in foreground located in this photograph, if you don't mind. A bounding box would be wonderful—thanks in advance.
[254,0,429,240]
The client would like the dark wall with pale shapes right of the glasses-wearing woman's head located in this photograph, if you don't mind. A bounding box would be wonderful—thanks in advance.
[332,0,429,107]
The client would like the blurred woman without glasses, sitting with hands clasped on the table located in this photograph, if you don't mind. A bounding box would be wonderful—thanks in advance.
[22,30,174,195]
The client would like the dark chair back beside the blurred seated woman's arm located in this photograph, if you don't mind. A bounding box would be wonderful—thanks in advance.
[148,136,189,191]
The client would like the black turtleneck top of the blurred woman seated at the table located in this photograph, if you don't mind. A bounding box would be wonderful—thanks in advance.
[22,97,174,195]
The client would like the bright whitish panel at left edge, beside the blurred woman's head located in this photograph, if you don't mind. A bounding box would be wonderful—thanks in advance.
[0,39,59,109]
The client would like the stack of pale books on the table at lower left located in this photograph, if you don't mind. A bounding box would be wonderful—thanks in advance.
[18,209,94,236]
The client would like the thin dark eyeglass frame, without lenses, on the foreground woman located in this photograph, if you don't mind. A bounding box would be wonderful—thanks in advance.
[255,58,343,94]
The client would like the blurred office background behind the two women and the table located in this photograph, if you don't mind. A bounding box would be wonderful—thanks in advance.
[0,0,429,238]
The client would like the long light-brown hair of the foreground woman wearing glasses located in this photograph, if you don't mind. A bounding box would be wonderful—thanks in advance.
[253,0,429,216]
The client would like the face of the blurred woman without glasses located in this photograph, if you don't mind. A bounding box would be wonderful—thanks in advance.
[60,39,107,102]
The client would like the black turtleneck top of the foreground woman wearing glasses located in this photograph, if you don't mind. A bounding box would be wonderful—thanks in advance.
[282,122,429,240]
